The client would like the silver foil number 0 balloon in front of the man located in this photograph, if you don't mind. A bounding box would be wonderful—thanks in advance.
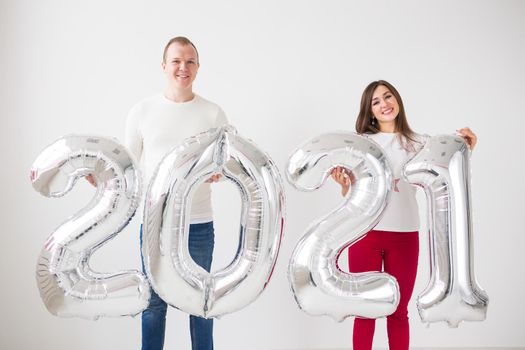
[142,126,284,318]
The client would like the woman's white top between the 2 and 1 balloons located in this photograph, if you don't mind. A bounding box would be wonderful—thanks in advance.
[364,132,426,232]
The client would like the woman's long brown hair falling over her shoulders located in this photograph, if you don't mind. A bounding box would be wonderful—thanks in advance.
[355,80,417,150]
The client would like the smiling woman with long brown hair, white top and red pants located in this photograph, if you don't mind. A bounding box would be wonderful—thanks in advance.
[332,80,477,350]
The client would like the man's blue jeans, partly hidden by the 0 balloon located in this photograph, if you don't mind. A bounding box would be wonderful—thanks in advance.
[140,222,215,350]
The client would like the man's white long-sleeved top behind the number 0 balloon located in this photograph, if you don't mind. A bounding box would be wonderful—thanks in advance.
[125,94,227,224]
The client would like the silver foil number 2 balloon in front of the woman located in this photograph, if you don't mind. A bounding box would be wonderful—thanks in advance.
[286,132,399,321]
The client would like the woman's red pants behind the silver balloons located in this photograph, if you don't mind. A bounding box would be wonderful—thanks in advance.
[348,230,419,350]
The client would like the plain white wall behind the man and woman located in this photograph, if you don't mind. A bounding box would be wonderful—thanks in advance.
[0,0,525,350]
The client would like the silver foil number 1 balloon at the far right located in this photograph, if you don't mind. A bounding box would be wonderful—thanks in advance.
[403,135,488,327]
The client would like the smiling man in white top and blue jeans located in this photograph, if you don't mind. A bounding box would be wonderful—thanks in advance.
[125,37,227,350]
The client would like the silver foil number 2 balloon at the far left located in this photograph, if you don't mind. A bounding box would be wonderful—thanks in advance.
[30,135,150,319]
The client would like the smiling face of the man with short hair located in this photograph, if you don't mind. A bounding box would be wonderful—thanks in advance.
[162,42,199,89]
